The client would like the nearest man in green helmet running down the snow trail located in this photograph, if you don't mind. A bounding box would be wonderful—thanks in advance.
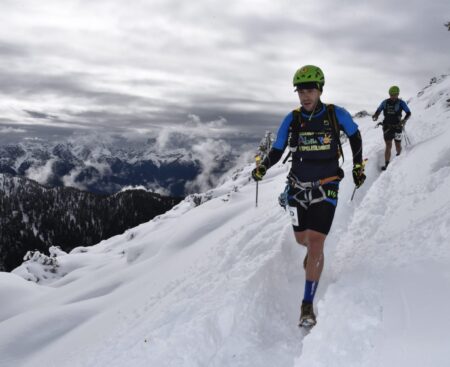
[252,65,366,327]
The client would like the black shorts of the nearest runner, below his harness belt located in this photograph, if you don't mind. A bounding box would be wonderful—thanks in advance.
[288,182,339,235]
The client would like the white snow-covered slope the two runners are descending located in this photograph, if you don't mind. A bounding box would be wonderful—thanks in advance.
[0,77,450,367]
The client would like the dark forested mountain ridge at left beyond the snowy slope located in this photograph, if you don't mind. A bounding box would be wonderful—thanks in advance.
[0,173,181,271]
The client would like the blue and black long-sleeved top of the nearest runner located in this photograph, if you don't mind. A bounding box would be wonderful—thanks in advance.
[262,101,362,182]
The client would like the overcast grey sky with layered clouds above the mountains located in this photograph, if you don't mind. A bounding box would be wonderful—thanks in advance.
[0,0,450,147]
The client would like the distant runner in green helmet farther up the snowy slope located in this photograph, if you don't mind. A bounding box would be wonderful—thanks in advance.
[372,85,411,171]
